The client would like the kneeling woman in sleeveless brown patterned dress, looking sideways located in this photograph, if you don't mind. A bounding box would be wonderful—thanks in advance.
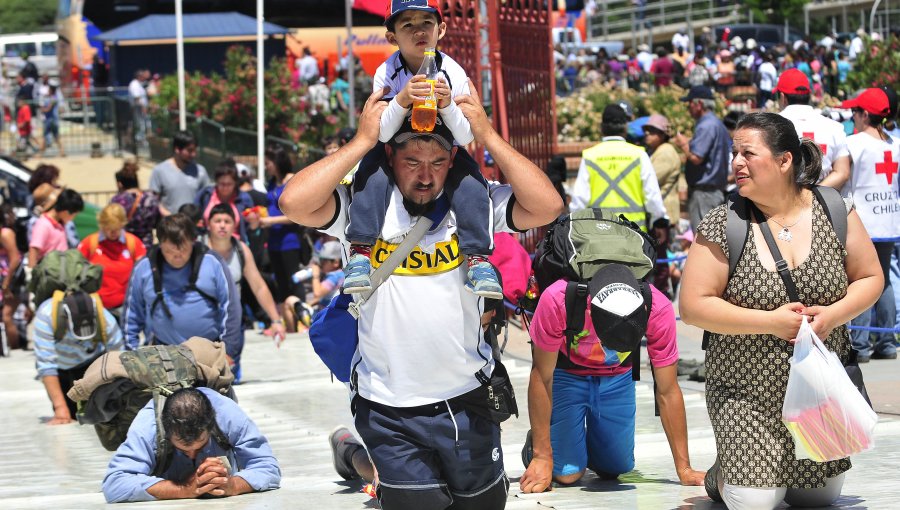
[680,113,883,510]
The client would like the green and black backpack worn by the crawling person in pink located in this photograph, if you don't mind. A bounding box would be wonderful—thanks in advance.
[532,208,656,381]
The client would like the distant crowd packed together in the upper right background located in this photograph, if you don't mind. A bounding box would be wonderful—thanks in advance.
[554,27,879,107]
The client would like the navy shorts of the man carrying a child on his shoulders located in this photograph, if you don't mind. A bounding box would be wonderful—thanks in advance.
[355,397,509,510]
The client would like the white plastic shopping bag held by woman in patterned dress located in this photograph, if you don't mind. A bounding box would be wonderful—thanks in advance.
[781,317,878,462]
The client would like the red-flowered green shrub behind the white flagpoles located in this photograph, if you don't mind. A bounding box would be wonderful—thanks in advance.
[151,46,347,146]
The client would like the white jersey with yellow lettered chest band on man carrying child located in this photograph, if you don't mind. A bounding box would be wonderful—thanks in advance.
[321,184,516,407]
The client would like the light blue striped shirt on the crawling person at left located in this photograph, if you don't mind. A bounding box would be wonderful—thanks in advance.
[34,299,124,378]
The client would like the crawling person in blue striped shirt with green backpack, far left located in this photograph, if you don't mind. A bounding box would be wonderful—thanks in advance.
[29,250,126,425]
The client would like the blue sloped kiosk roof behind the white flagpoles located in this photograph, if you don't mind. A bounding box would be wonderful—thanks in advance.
[97,12,289,45]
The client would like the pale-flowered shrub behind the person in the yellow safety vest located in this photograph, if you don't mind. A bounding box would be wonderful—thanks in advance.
[556,83,725,142]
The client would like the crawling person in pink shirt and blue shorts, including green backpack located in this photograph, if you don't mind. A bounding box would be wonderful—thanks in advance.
[519,209,705,493]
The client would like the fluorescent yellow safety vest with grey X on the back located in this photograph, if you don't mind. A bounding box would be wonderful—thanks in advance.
[581,140,647,231]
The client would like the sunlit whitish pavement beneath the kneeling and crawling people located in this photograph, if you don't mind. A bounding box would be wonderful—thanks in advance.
[0,312,900,510]
